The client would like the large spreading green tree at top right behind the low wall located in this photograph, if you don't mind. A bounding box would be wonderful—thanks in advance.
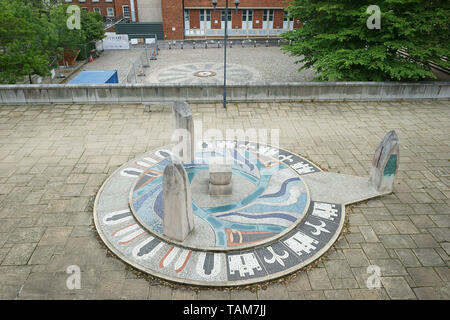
[284,0,450,81]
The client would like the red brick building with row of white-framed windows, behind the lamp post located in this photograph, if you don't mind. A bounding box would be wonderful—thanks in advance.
[160,0,301,40]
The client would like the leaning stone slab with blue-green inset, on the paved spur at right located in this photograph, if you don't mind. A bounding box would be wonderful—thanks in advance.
[369,130,399,193]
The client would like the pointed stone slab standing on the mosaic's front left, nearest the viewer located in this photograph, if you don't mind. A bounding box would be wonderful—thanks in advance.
[163,160,194,241]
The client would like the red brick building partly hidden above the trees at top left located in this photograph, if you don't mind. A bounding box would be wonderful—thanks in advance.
[64,0,139,22]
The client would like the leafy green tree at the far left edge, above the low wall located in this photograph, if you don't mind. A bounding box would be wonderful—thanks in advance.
[0,0,55,83]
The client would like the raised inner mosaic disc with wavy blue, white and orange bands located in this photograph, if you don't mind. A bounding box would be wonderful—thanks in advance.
[130,143,309,249]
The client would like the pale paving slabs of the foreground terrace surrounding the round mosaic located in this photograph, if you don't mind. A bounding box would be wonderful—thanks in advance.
[0,101,450,299]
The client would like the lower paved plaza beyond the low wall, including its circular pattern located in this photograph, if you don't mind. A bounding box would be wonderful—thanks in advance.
[74,46,314,83]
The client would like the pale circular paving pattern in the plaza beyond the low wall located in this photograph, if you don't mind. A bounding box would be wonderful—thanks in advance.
[154,63,259,84]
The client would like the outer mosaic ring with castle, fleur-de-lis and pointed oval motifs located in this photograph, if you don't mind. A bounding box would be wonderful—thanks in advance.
[94,141,345,287]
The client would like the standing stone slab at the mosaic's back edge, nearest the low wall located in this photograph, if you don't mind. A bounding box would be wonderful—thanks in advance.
[172,101,195,163]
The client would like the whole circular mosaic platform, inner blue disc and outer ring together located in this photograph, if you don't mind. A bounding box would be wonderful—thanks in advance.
[94,141,345,286]
